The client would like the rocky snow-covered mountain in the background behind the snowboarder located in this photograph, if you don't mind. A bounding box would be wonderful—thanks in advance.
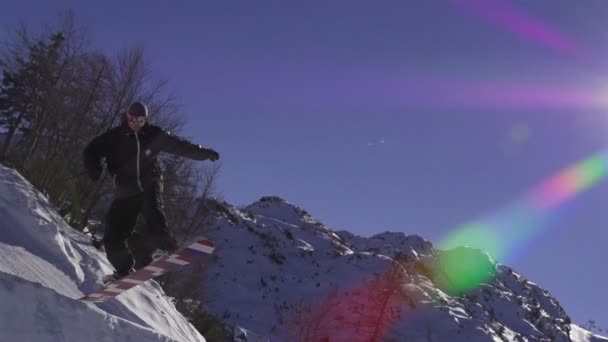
[188,197,608,342]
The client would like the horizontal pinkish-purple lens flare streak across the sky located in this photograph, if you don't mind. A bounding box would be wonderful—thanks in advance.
[205,66,608,112]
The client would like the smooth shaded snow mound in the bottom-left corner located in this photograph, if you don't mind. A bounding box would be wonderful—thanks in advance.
[0,272,171,342]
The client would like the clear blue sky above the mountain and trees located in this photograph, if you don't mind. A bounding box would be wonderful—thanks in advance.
[0,0,608,327]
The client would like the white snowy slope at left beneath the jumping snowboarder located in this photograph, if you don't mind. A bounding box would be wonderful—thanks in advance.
[0,166,204,341]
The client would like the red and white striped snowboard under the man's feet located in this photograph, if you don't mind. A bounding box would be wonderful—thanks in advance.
[80,236,215,303]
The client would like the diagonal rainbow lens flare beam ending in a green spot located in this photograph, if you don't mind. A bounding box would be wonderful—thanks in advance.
[439,151,608,291]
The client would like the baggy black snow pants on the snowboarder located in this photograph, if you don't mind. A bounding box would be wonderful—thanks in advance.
[103,187,177,274]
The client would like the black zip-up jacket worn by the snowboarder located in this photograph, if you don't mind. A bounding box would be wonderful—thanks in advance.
[83,121,215,197]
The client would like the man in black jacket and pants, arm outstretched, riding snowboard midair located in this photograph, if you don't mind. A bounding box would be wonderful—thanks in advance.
[83,102,219,282]
